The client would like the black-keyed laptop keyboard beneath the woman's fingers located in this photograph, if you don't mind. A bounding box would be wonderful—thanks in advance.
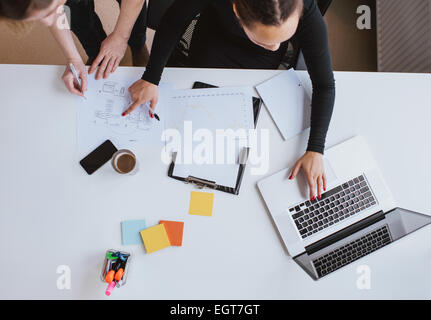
[289,175,376,239]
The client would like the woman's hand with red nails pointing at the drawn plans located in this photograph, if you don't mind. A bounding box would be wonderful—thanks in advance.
[122,80,159,117]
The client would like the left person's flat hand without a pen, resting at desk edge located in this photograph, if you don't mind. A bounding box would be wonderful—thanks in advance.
[88,32,128,80]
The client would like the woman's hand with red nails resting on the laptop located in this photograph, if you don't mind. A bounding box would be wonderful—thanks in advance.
[289,151,326,201]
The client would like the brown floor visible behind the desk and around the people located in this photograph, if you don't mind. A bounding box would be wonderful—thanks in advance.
[0,0,377,71]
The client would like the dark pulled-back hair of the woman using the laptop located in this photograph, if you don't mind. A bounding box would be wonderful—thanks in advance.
[233,0,303,26]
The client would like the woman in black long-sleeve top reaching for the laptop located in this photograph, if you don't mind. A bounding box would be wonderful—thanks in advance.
[123,0,335,200]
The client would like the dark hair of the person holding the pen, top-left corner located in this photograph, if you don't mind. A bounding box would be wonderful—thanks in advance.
[0,0,52,20]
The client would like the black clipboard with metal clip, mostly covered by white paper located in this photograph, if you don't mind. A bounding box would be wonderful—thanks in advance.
[168,82,262,195]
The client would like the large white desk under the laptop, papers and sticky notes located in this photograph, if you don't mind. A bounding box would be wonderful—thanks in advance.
[0,65,431,299]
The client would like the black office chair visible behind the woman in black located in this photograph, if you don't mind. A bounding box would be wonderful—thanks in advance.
[147,0,332,70]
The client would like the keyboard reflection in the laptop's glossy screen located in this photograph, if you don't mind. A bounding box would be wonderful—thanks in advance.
[313,226,391,277]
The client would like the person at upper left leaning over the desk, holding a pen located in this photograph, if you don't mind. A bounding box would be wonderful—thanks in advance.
[0,0,148,96]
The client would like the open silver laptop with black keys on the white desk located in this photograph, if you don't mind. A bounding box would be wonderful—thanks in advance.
[258,136,431,280]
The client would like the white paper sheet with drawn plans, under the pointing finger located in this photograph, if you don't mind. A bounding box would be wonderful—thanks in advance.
[77,75,173,154]
